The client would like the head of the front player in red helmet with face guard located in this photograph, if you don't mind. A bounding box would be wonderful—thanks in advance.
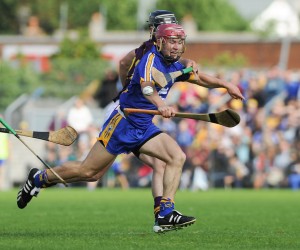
[155,23,186,63]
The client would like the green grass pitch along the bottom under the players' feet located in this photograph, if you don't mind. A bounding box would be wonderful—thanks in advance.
[0,188,300,250]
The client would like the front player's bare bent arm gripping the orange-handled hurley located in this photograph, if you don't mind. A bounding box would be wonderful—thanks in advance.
[141,82,175,118]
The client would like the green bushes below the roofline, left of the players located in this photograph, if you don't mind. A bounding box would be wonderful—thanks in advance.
[0,38,109,111]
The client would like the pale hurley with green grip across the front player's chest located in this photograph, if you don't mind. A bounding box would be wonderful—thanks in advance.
[152,67,193,88]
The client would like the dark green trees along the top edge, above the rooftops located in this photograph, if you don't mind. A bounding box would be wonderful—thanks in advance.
[0,0,249,34]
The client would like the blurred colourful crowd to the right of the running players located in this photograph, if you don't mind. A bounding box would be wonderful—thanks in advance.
[151,66,300,190]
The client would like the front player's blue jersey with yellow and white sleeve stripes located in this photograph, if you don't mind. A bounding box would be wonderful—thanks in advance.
[120,46,189,129]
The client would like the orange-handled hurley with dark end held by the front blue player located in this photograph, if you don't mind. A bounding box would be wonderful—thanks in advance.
[124,108,241,128]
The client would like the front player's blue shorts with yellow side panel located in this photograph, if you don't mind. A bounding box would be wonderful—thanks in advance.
[98,110,161,155]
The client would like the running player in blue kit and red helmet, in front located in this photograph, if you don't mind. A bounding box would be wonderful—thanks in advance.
[17,24,244,232]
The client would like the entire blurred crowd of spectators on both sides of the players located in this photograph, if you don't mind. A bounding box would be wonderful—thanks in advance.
[2,66,300,190]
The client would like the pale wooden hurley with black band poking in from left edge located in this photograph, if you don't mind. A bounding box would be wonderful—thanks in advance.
[0,126,78,146]
